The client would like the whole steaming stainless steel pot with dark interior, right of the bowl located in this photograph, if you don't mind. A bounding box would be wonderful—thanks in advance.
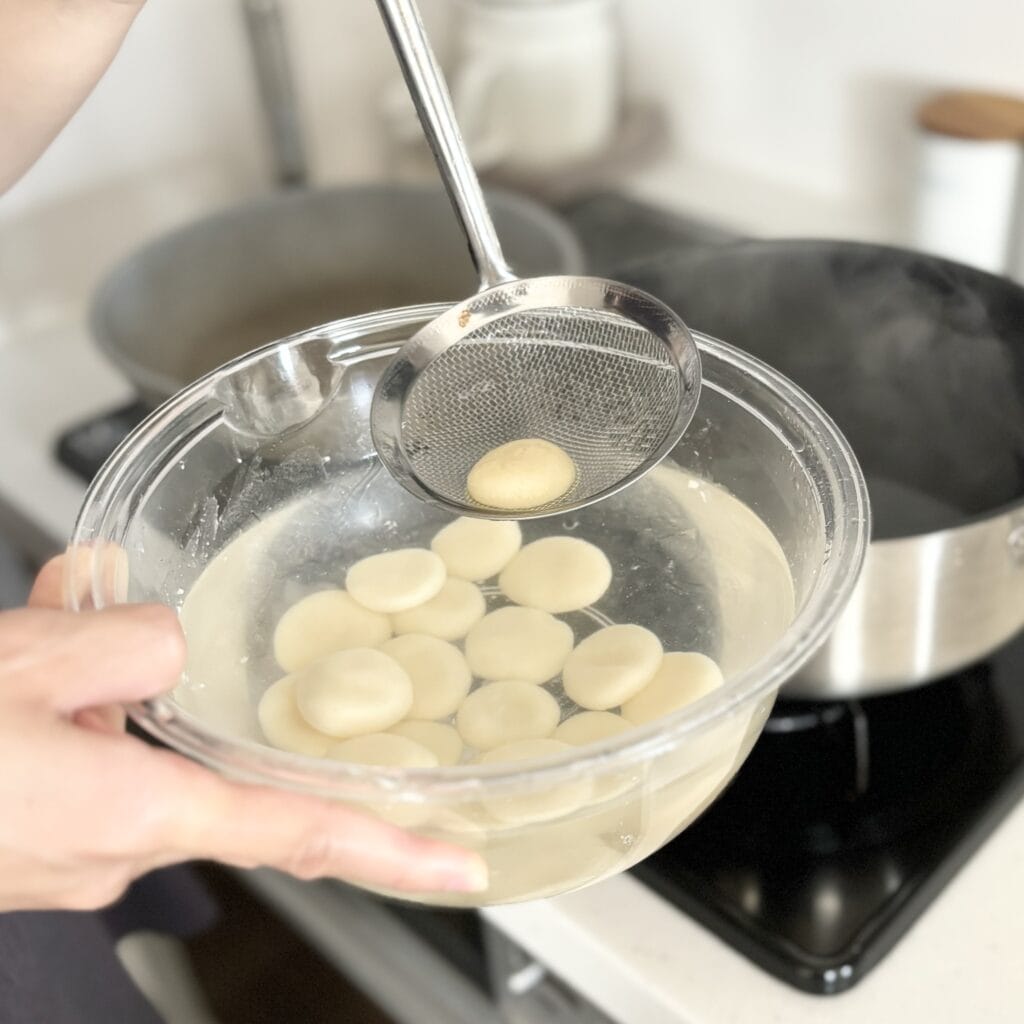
[618,241,1024,698]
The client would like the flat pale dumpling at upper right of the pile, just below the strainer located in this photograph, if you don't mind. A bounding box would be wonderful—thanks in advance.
[498,537,611,613]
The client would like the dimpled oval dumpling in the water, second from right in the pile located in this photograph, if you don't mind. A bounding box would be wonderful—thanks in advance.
[562,625,663,711]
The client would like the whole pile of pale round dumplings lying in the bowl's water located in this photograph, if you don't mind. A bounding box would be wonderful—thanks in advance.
[258,518,722,768]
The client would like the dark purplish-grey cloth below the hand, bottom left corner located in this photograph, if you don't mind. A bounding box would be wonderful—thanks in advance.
[0,867,217,1024]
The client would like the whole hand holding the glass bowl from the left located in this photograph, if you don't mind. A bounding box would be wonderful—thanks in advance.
[0,560,485,910]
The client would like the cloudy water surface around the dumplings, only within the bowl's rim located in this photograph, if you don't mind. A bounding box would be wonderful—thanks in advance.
[178,452,795,739]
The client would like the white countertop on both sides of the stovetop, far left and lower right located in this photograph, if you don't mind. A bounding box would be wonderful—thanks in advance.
[0,182,1024,1024]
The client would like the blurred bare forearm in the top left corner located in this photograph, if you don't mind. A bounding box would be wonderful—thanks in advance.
[0,0,144,193]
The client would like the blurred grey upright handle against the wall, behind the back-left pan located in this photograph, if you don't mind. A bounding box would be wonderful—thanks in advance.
[242,0,308,186]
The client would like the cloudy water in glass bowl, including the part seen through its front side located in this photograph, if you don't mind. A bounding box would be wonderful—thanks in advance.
[176,449,795,903]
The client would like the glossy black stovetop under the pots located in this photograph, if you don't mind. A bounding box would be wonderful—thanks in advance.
[57,195,1024,993]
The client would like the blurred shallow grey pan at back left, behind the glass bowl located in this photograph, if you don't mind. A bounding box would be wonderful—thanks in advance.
[90,184,584,404]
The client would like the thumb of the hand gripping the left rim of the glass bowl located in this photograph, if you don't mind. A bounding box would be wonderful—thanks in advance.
[0,604,185,715]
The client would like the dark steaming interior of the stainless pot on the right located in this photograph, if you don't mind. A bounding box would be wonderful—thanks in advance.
[622,241,1024,540]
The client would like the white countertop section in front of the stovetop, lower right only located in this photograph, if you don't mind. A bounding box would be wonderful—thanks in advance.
[484,804,1024,1024]
